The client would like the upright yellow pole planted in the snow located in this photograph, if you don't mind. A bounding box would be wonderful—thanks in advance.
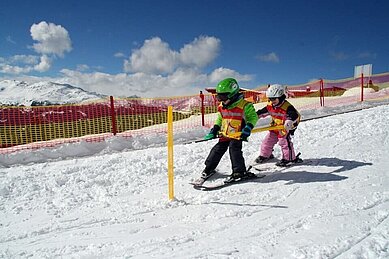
[167,106,174,200]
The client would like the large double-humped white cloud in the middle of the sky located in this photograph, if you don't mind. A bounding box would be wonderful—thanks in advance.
[124,36,220,74]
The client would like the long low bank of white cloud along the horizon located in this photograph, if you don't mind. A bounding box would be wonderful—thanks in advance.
[50,67,252,97]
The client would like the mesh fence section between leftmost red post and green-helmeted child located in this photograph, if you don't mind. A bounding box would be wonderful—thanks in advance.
[114,95,218,137]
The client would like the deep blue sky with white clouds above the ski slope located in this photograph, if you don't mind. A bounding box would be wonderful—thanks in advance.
[0,0,389,97]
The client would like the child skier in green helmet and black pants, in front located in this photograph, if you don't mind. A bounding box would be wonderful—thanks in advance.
[199,78,258,185]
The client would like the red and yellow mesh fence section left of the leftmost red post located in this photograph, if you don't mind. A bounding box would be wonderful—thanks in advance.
[0,102,111,151]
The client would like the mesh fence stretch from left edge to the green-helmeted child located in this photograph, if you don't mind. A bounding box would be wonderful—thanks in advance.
[0,95,218,153]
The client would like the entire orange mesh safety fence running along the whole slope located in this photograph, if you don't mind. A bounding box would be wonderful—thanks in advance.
[0,73,389,154]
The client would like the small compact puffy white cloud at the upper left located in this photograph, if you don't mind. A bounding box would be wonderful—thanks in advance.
[30,21,72,57]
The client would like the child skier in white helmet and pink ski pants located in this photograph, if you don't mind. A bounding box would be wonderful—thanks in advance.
[255,84,302,167]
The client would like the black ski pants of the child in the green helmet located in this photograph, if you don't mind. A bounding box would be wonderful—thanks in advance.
[205,139,246,173]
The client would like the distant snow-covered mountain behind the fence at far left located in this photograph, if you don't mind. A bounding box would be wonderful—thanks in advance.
[0,80,106,106]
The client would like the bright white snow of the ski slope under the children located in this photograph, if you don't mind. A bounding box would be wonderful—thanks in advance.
[0,88,389,258]
